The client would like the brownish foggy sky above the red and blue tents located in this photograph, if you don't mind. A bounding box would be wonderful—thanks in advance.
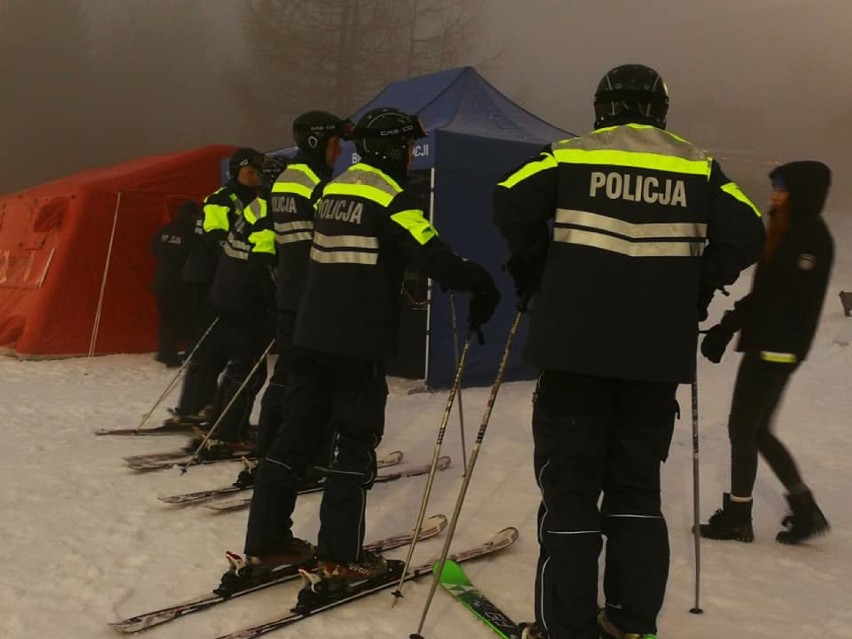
[0,0,852,206]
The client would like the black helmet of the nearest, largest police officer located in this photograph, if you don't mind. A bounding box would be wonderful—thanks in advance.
[595,64,669,129]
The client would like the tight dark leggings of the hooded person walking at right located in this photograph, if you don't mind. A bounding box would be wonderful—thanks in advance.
[728,352,802,497]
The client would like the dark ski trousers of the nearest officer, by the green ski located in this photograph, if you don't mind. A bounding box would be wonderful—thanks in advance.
[533,371,677,639]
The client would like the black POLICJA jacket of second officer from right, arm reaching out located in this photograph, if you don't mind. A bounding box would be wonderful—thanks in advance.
[293,161,494,361]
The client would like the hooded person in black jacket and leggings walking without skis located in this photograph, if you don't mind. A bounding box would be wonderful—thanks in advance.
[701,161,834,544]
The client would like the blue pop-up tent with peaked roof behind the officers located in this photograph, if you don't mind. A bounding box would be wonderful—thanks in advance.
[276,67,569,387]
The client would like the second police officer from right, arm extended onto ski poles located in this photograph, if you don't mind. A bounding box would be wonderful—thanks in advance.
[230,108,499,589]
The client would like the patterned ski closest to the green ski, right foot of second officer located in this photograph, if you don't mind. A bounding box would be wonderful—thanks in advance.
[216,527,518,639]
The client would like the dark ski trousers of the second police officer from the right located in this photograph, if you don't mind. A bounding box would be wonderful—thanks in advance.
[245,349,388,562]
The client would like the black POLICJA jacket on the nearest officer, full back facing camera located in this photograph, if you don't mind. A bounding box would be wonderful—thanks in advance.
[494,124,765,383]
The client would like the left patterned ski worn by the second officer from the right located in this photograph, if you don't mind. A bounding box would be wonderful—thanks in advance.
[109,515,447,633]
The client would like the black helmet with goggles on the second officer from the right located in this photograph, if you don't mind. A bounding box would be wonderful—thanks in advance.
[352,107,426,166]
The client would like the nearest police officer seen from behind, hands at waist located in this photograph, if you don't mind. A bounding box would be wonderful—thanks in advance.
[494,64,764,639]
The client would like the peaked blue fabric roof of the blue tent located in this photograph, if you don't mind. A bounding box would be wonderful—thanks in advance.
[353,67,566,144]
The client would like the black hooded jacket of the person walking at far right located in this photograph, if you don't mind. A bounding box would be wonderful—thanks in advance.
[723,161,834,361]
